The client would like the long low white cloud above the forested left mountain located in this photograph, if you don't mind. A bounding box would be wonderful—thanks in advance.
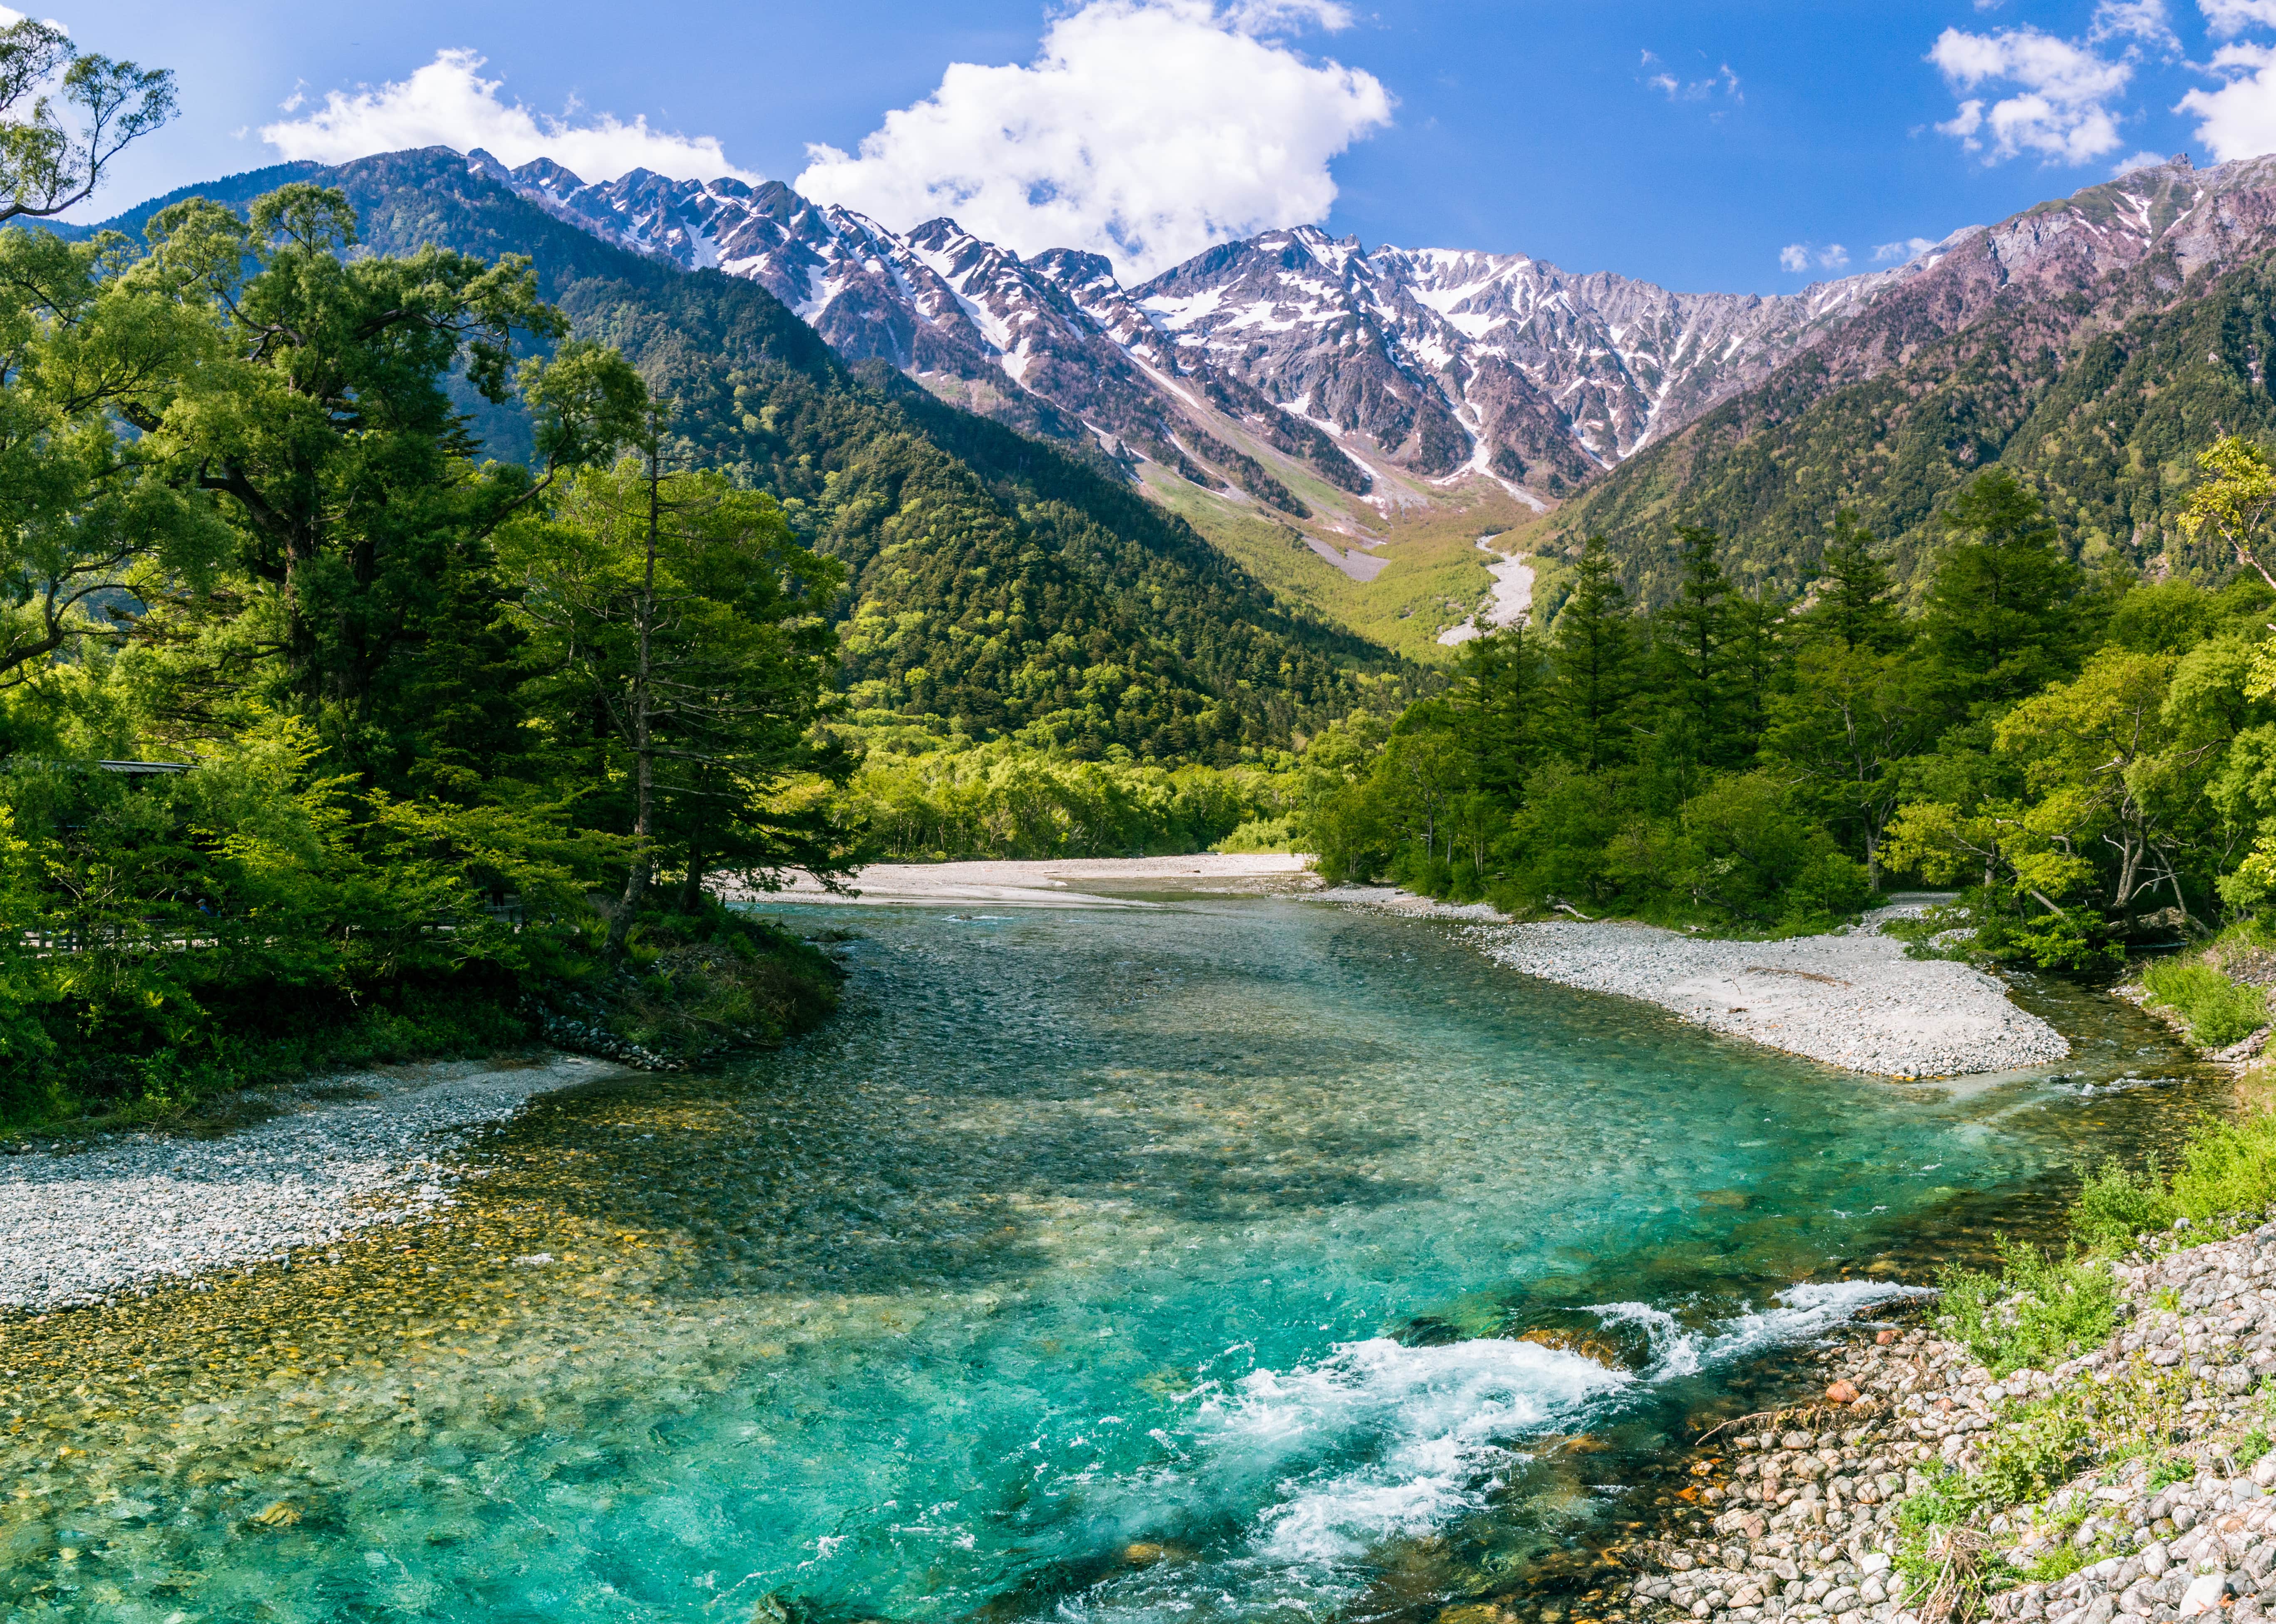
[262,50,758,180]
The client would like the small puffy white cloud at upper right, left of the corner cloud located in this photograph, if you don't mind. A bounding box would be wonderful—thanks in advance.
[1928,22,2162,164]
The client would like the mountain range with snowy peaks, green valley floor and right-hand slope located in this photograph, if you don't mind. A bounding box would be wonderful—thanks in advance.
[66,138,2276,695]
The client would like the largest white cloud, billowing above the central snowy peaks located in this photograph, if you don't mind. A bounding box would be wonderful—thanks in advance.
[797,0,1393,278]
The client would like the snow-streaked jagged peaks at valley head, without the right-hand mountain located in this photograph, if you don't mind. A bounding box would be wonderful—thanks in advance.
[469,150,1935,512]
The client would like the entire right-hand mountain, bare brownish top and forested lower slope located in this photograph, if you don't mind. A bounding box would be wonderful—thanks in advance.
[1554,157,2276,597]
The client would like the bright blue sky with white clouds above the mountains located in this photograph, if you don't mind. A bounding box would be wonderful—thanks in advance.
[52,0,2276,294]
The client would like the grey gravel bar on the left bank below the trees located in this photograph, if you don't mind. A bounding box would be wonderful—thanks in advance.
[0,1055,626,1312]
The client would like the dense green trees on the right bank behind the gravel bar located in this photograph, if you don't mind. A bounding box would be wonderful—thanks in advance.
[1309,449,2276,968]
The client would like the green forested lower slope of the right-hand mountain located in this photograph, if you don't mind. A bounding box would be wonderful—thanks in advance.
[1550,247,2276,603]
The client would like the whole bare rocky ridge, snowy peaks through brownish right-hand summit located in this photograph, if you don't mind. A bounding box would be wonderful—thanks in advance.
[469,153,2276,542]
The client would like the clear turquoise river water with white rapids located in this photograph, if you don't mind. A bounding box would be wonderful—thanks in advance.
[0,900,2219,1624]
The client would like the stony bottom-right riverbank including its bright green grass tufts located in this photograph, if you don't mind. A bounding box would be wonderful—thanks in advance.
[1632,1112,2276,1624]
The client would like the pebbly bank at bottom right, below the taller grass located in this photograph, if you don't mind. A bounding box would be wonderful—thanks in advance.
[1627,1223,2276,1624]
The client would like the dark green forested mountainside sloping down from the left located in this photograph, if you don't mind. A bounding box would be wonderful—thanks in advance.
[98,150,1407,761]
